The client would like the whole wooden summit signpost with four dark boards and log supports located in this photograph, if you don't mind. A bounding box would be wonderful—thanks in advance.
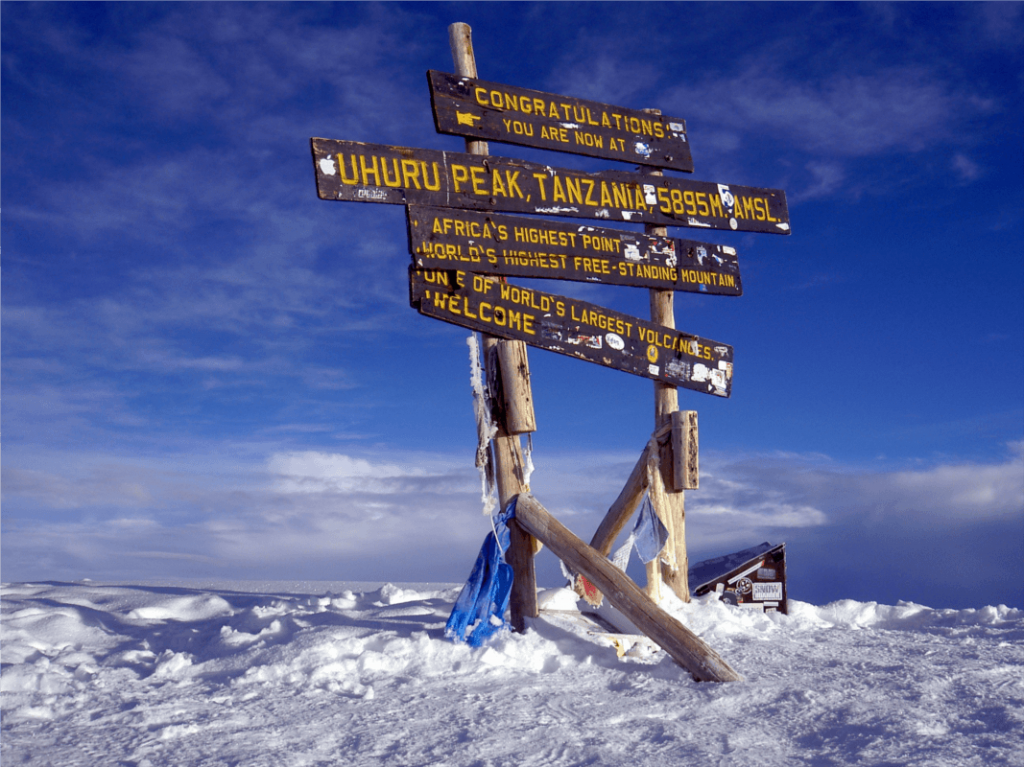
[310,24,790,681]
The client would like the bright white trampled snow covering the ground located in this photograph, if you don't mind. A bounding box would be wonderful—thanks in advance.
[0,582,1024,767]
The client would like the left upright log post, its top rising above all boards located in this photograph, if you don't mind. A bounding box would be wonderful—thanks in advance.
[449,23,538,631]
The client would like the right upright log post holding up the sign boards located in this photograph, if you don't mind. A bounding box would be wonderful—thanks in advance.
[644,110,690,602]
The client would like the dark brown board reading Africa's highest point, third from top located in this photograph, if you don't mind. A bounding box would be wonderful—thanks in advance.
[406,205,743,296]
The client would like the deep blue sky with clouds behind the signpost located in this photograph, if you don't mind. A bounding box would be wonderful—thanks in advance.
[6,0,1024,607]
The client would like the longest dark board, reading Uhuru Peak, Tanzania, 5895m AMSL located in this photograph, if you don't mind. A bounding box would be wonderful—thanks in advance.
[311,138,790,235]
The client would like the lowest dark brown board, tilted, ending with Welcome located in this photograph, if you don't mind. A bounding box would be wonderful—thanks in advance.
[409,268,732,397]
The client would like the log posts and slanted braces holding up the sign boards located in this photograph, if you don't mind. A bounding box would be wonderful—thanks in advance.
[449,24,742,682]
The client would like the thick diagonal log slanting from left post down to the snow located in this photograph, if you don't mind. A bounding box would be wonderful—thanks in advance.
[515,494,742,682]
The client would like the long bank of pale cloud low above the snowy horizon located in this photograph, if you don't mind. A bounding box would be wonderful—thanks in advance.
[3,444,1024,598]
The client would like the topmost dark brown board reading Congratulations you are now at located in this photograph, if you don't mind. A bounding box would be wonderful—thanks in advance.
[427,70,693,172]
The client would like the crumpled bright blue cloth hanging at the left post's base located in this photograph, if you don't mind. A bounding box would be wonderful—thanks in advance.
[444,497,518,647]
